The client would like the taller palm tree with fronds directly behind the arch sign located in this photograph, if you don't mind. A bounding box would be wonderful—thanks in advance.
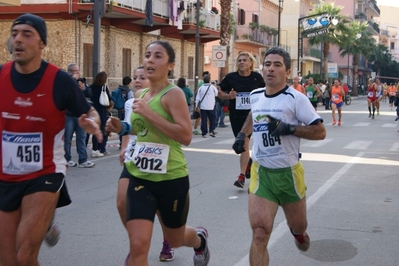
[309,2,349,80]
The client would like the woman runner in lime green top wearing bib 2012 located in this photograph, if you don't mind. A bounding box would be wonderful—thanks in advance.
[107,41,209,266]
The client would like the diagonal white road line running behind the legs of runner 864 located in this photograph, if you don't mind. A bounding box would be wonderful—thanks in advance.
[234,152,364,266]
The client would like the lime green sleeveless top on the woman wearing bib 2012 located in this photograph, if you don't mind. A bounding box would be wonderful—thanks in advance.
[125,84,188,182]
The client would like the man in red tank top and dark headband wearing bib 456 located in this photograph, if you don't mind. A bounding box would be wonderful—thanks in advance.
[0,14,102,265]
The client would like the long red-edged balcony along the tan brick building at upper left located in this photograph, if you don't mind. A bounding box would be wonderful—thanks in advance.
[0,0,220,43]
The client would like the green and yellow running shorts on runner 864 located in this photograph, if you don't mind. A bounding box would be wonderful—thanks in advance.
[248,162,306,206]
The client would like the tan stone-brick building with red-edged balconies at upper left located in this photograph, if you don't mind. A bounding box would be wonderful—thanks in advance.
[0,0,220,89]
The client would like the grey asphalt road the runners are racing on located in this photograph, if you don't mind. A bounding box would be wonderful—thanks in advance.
[39,98,399,266]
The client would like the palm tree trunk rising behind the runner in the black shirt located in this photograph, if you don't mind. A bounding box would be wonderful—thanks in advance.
[220,0,234,79]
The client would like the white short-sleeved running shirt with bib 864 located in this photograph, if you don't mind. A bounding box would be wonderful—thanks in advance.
[251,86,322,169]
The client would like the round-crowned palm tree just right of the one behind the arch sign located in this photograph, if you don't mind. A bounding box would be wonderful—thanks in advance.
[337,21,376,96]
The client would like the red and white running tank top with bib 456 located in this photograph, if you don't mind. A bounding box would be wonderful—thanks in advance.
[0,62,66,182]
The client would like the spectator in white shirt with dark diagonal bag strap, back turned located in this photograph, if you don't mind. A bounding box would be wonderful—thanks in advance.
[195,75,218,138]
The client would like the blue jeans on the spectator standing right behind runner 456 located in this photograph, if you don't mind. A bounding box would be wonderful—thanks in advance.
[64,115,87,164]
